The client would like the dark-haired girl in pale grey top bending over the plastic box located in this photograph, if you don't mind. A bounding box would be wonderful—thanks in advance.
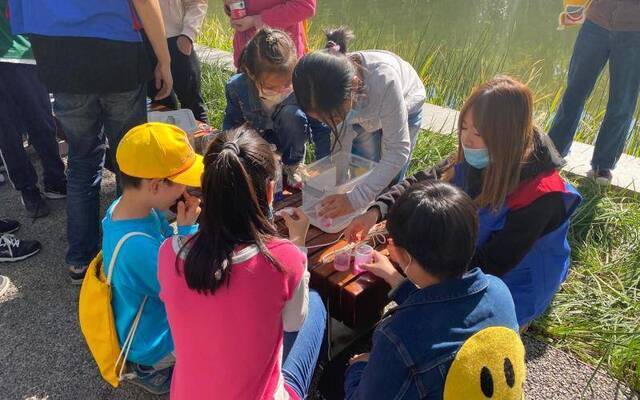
[293,28,426,218]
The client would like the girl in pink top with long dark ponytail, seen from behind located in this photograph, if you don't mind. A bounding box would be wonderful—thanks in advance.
[158,127,326,400]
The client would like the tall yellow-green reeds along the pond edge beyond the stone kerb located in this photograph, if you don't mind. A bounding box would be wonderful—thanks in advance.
[198,13,640,156]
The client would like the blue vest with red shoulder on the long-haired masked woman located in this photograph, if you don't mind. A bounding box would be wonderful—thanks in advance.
[452,164,582,326]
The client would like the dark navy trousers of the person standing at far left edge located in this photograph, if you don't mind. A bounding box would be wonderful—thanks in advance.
[0,63,66,190]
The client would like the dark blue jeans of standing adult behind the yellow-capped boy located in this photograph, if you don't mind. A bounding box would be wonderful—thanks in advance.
[54,85,147,266]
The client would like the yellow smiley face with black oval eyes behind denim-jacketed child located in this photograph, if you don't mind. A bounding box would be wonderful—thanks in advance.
[444,327,526,400]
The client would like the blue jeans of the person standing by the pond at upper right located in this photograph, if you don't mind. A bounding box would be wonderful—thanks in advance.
[549,20,640,170]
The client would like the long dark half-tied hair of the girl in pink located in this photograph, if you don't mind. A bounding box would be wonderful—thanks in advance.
[176,125,282,294]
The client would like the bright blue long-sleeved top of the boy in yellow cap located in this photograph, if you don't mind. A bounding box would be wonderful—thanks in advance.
[102,199,198,366]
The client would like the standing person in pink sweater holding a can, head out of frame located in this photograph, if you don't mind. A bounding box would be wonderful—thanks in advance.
[224,0,316,67]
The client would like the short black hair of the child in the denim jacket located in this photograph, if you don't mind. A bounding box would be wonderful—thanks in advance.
[387,180,478,280]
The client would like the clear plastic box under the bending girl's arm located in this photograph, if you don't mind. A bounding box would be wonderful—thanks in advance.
[302,153,378,233]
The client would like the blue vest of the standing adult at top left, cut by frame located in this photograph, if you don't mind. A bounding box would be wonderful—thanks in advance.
[9,0,142,42]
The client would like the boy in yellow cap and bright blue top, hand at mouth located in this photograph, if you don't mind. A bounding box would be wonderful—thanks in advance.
[102,123,203,394]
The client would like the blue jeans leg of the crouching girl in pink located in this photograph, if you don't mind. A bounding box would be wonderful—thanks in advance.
[282,290,327,399]
